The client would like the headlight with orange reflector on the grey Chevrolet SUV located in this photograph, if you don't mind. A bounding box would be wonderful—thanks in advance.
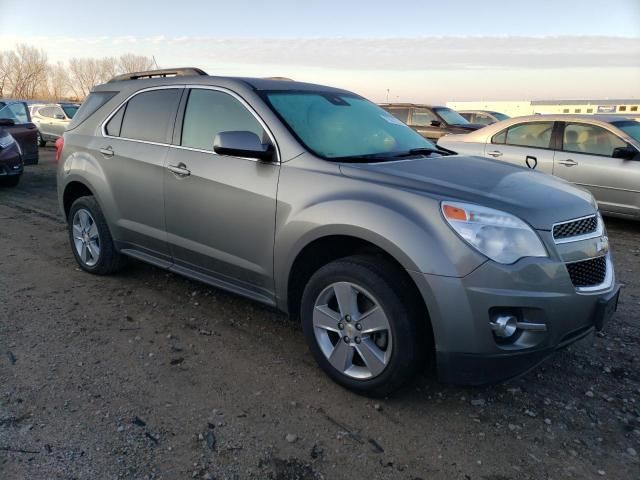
[441,202,547,264]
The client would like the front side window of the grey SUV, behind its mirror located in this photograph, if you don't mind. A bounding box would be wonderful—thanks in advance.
[180,89,269,151]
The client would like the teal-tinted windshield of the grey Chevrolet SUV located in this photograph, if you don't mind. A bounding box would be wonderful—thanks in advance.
[265,91,435,160]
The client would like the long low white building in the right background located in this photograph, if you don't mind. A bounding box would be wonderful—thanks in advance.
[447,98,640,118]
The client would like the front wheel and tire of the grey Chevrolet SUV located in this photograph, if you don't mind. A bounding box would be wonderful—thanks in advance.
[301,255,428,397]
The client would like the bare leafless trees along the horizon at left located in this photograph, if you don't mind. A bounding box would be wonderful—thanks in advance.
[0,44,155,101]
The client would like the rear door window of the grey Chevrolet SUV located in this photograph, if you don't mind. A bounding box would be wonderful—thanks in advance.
[120,88,180,143]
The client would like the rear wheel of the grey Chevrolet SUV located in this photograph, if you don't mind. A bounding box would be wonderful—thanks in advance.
[68,197,126,275]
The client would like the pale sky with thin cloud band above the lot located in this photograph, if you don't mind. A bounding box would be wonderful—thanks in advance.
[0,0,640,102]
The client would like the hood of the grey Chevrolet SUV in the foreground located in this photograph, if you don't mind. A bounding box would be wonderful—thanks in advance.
[340,155,596,230]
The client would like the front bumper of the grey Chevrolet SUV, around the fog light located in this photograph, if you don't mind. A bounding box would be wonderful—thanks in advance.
[412,251,620,385]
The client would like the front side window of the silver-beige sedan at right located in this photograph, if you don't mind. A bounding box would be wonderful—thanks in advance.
[562,123,627,157]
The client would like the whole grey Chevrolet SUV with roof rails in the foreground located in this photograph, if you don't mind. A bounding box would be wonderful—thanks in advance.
[58,69,619,395]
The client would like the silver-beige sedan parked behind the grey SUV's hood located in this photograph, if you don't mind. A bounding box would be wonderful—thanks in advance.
[438,115,640,220]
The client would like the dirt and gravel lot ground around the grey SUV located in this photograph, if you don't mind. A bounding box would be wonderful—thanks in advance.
[0,149,640,480]
